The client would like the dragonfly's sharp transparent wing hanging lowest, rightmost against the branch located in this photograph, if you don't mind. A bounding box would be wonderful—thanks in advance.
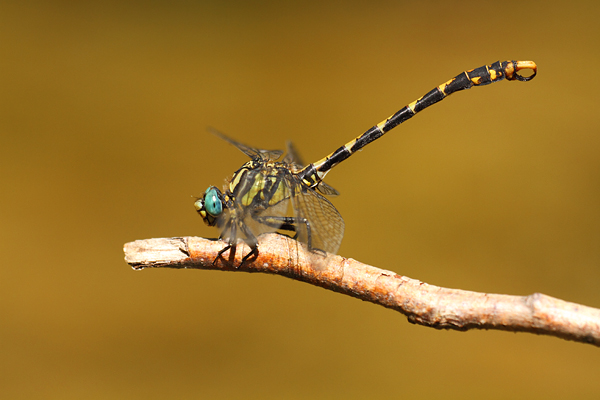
[289,176,344,254]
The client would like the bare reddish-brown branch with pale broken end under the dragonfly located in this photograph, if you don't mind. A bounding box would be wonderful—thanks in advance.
[123,234,600,346]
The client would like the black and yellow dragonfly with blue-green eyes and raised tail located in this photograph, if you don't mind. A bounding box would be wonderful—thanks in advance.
[194,61,537,266]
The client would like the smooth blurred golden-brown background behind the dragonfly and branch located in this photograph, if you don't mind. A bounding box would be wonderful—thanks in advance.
[0,1,600,399]
